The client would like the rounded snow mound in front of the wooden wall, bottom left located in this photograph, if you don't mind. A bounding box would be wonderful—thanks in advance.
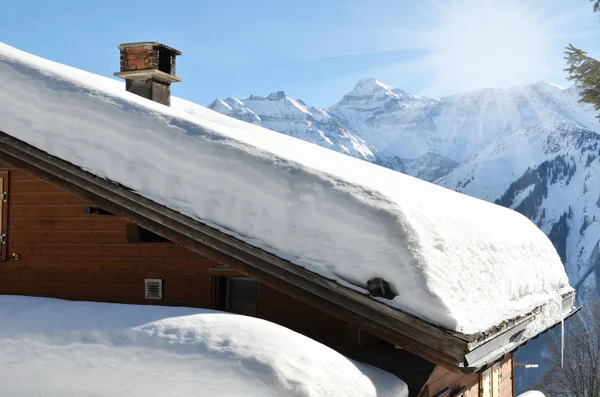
[0,296,408,397]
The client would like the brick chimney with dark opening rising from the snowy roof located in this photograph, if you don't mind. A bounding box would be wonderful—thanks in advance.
[114,42,181,106]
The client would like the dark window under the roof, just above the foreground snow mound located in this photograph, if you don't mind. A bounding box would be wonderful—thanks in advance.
[215,277,258,316]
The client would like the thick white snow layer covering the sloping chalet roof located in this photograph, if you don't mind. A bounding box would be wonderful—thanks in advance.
[0,45,572,334]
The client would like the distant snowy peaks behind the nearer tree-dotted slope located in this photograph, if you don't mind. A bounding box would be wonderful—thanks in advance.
[210,78,598,181]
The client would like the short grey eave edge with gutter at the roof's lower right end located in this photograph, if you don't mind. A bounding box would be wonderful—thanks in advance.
[461,291,581,372]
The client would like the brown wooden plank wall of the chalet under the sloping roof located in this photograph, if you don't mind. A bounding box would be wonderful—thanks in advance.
[0,158,358,344]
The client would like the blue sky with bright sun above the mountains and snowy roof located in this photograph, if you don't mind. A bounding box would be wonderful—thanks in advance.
[0,0,600,107]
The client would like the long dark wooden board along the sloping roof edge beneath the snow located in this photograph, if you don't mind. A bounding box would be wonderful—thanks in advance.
[0,132,470,370]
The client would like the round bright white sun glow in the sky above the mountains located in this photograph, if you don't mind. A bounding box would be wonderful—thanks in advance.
[434,1,550,87]
